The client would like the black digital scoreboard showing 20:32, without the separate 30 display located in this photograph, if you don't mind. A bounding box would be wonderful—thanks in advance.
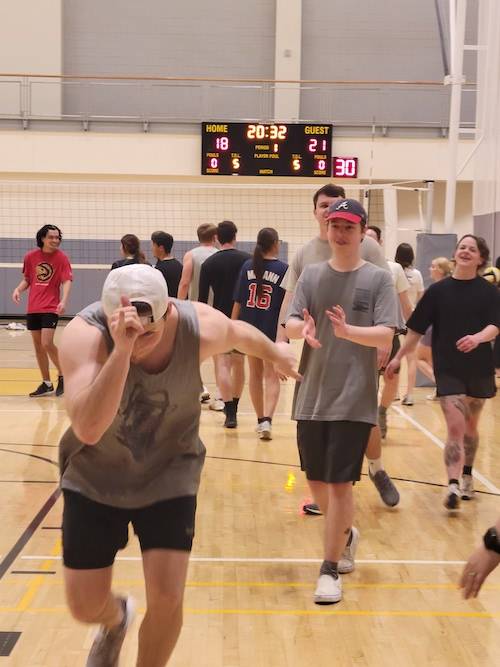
[201,122,333,178]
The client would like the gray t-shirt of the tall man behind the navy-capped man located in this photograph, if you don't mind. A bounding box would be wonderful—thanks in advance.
[283,236,389,292]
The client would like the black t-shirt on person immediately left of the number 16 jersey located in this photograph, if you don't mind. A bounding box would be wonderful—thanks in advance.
[198,248,250,317]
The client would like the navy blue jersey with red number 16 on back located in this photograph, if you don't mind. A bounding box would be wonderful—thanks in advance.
[234,259,288,340]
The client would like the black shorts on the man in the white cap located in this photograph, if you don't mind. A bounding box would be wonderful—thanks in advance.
[62,489,196,570]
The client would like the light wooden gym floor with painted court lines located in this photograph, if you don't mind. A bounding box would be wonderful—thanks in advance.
[0,329,500,667]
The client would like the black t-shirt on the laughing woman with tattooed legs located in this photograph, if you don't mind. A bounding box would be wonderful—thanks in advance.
[407,277,500,378]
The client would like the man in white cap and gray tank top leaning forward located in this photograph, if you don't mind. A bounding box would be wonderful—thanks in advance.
[60,264,299,667]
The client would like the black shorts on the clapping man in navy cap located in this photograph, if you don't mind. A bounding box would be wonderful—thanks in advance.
[297,420,373,484]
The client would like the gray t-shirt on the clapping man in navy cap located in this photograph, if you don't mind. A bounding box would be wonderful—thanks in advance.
[287,262,397,424]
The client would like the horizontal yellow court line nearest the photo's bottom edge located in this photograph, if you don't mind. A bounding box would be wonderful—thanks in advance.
[0,607,500,619]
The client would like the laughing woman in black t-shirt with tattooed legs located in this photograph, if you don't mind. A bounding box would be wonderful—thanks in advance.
[386,234,500,510]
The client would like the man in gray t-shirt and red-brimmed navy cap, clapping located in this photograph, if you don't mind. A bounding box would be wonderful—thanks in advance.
[285,199,397,604]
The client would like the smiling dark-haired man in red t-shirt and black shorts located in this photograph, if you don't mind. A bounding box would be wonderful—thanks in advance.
[12,225,73,396]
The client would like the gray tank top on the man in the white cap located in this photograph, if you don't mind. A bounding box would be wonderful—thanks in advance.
[59,299,205,508]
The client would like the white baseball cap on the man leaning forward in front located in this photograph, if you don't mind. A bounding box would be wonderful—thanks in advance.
[101,264,168,322]
